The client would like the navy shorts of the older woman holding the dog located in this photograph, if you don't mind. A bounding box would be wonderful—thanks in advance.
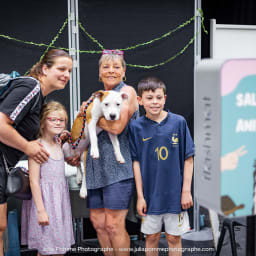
[87,179,135,210]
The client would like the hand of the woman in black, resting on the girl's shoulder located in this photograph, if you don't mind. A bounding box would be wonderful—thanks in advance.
[24,140,49,164]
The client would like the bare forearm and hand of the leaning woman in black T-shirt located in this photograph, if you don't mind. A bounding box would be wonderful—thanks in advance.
[0,112,49,163]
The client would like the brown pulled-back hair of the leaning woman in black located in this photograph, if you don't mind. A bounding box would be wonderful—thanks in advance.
[28,49,72,79]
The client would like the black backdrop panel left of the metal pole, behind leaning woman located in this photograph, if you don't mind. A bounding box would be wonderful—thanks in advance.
[0,0,69,122]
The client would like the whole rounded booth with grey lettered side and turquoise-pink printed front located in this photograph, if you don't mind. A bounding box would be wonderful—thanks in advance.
[195,59,256,216]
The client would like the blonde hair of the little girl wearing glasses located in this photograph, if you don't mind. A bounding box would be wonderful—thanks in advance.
[38,101,68,137]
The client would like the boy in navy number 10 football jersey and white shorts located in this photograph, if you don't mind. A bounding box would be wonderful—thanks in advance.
[129,77,194,256]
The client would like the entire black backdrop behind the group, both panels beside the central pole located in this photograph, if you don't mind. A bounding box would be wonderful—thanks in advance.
[0,0,194,134]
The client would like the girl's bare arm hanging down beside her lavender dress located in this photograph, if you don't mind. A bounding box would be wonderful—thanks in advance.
[28,158,49,225]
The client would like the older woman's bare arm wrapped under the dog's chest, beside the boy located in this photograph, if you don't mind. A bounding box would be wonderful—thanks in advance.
[97,86,138,135]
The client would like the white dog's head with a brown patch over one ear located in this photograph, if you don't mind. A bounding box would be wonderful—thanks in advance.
[96,91,128,121]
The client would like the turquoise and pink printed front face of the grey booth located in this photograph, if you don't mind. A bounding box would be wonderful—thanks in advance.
[220,60,256,216]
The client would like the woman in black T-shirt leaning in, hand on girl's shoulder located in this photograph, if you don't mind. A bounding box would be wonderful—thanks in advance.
[0,49,72,256]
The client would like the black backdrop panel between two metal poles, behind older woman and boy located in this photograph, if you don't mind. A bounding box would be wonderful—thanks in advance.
[79,0,194,136]
